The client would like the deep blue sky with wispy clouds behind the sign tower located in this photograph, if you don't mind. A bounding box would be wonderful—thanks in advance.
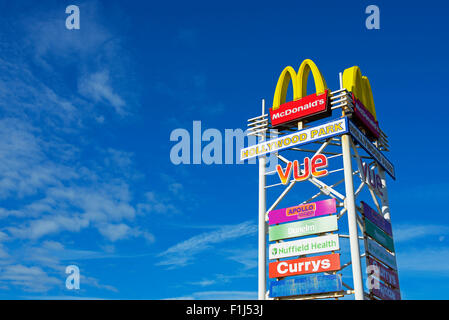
[0,1,449,299]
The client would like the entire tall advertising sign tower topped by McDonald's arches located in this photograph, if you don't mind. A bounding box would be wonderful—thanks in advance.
[240,59,400,300]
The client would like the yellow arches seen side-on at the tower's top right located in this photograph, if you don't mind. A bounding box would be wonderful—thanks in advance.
[343,66,377,121]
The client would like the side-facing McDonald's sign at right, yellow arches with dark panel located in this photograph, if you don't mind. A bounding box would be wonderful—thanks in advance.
[343,66,380,139]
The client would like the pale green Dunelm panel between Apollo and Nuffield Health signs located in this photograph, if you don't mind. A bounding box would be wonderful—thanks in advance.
[268,215,338,241]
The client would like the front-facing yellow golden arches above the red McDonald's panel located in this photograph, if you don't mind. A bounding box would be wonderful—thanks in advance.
[272,59,327,110]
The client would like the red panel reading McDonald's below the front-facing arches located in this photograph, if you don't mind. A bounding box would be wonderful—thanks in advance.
[270,90,330,127]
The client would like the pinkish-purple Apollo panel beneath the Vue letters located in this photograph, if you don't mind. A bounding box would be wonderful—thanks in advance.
[268,199,337,225]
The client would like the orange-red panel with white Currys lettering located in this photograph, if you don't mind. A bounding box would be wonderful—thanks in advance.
[268,253,340,278]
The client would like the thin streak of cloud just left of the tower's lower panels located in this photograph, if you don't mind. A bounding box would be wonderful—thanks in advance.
[157,221,257,268]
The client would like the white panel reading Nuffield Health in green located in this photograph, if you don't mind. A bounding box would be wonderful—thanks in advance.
[269,234,340,260]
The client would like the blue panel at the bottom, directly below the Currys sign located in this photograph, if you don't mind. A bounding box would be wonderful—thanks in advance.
[270,274,343,298]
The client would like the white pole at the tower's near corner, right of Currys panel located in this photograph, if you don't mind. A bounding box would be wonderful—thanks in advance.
[339,72,364,300]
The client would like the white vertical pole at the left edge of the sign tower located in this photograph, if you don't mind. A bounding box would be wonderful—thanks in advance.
[258,99,267,300]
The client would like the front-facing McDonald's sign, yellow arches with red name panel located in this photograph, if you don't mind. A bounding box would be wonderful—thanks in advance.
[270,59,332,127]
